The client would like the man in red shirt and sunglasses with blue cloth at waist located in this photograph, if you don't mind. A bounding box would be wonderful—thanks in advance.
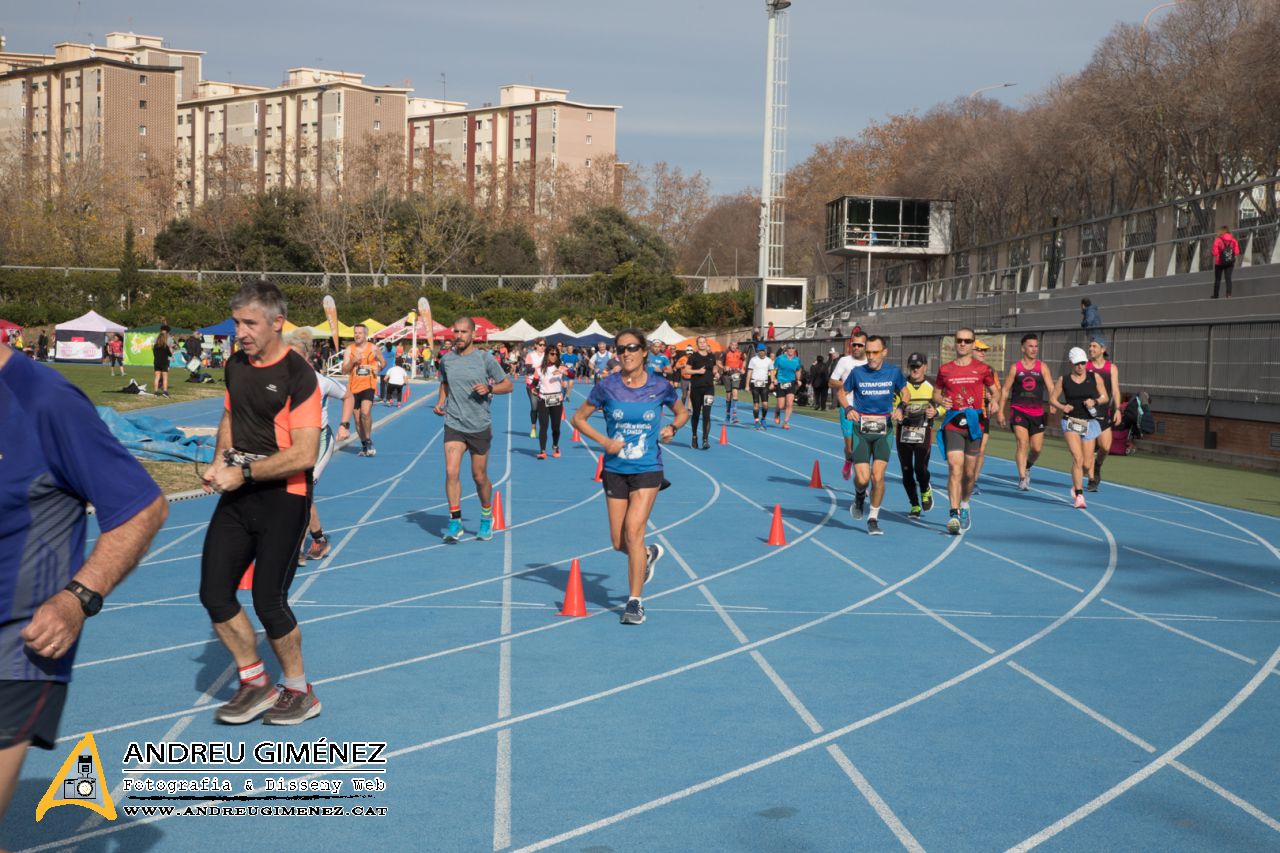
[933,328,1000,535]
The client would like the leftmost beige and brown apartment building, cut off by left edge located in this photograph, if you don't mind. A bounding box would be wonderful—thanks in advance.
[0,33,192,194]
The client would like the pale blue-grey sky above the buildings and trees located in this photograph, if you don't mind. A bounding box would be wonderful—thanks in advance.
[10,0,1167,192]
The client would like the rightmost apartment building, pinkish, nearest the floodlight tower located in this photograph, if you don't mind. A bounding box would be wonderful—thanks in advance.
[408,85,621,205]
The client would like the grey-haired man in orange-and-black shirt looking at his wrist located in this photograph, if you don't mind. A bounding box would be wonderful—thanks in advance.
[200,280,321,725]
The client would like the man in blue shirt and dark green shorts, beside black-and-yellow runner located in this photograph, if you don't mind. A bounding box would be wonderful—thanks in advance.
[836,334,906,535]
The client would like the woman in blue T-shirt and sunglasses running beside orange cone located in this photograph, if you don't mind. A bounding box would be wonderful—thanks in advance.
[573,329,689,625]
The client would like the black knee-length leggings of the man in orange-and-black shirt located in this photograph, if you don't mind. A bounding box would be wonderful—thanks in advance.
[200,485,311,639]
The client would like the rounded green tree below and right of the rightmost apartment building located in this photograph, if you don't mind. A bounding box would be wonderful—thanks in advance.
[556,207,672,273]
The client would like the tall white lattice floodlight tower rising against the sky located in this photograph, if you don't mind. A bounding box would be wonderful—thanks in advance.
[758,0,791,279]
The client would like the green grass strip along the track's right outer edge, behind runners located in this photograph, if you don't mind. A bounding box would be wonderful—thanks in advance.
[716,391,1280,516]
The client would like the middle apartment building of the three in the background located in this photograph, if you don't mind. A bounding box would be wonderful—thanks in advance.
[175,68,412,204]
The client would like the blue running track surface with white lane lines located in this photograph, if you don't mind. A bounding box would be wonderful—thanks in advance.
[0,386,1280,853]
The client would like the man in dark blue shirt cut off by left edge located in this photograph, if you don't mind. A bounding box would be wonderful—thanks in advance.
[0,343,169,822]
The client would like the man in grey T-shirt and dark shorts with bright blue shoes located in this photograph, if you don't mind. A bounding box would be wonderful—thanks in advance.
[435,316,511,544]
